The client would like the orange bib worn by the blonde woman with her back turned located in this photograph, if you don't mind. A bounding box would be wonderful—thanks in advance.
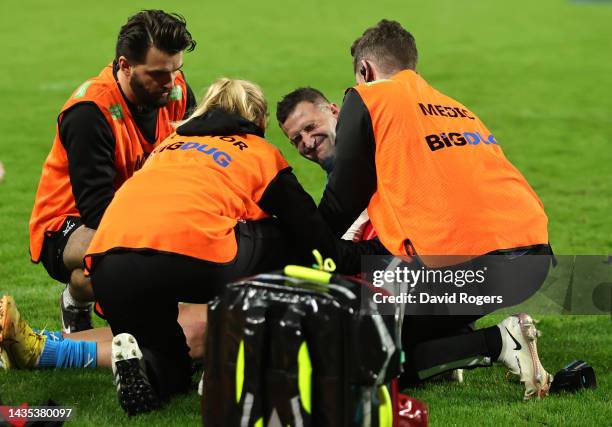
[85,134,288,271]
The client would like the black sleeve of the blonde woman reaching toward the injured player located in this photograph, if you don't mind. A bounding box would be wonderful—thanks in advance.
[258,168,388,274]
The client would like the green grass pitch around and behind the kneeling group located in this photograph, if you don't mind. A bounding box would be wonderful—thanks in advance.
[0,0,612,426]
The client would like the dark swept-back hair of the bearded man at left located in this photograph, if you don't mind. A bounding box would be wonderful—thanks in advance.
[115,9,196,64]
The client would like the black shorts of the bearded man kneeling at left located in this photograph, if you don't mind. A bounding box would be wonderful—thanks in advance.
[40,216,83,283]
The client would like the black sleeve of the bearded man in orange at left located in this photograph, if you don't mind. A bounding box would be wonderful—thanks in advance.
[59,103,116,229]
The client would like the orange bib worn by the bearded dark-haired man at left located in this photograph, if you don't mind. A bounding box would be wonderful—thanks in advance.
[30,64,187,262]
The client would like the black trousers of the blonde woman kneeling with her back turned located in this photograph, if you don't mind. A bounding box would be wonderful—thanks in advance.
[91,219,292,399]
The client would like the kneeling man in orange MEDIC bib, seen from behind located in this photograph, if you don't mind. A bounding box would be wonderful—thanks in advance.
[319,20,552,399]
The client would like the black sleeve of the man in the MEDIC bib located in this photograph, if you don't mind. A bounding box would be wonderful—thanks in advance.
[319,89,376,237]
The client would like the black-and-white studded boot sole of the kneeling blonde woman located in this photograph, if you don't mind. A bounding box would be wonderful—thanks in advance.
[111,334,160,416]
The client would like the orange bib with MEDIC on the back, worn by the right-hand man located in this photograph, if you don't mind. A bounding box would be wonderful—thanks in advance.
[355,70,548,266]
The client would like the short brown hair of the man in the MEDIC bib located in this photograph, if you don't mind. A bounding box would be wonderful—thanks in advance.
[351,19,418,74]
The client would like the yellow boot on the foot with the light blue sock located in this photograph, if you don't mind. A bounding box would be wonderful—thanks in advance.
[0,295,47,368]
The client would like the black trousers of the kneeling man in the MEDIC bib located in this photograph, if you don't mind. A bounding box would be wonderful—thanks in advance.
[400,245,553,386]
